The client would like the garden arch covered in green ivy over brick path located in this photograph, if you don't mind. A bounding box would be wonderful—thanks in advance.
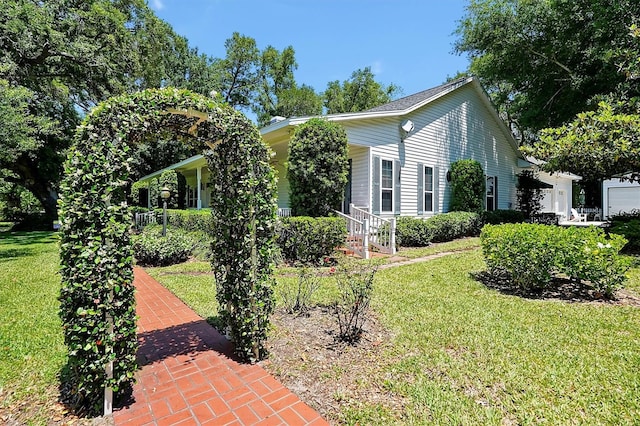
[59,88,276,408]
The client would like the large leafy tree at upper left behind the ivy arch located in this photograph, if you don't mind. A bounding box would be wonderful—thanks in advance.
[0,0,204,223]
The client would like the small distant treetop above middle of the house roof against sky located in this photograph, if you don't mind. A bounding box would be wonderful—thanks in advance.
[324,67,401,114]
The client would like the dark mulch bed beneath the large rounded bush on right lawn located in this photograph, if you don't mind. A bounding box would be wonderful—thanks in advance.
[470,271,606,303]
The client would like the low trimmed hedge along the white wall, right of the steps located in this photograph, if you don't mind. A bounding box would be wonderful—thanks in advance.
[396,212,481,247]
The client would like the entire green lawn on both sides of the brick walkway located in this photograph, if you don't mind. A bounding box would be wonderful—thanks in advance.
[0,232,640,425]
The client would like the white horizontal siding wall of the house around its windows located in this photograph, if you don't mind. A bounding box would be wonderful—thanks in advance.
[342,85,518,216]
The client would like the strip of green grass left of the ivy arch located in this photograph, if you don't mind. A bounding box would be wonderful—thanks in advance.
[0,232,66,423]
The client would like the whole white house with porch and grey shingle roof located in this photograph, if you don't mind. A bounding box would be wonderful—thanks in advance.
[135,77,576,255]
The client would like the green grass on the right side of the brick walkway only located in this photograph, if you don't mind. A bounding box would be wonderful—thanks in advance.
[151,245,640,425]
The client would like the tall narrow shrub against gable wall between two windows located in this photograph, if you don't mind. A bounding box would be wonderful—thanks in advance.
[449,159,487,212]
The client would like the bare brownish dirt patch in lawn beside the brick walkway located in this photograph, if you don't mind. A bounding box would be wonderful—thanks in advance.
[261,307,405,423]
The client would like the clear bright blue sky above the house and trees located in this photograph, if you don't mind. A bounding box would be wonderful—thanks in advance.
[148,0,468,99]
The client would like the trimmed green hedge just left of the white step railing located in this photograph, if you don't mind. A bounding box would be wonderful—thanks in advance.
[276,216,347,264]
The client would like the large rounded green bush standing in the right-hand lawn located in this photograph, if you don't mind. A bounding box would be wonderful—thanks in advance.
[480,223,630,297]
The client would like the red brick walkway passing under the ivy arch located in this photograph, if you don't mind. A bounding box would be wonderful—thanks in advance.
[113,268,328,426]
